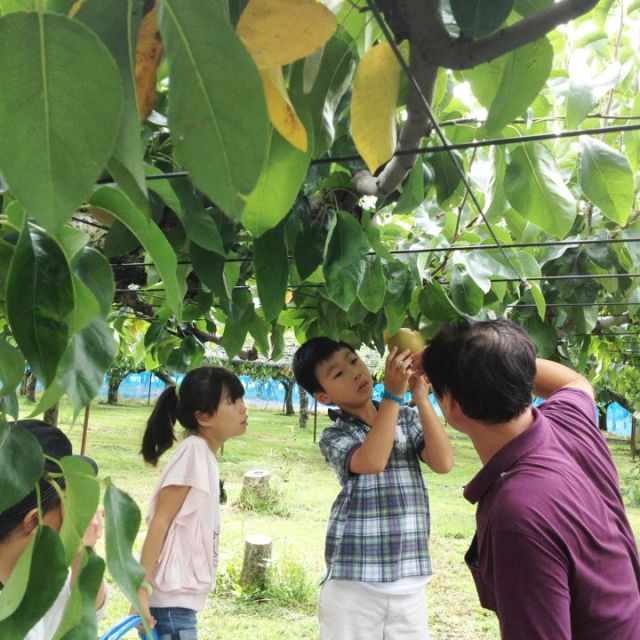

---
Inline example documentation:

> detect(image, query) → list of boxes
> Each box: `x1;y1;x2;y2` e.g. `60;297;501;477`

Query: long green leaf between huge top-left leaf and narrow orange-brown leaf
73;0;148;211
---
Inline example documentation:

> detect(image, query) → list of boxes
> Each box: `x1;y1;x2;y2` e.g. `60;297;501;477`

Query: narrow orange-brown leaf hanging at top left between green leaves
136;0;163;121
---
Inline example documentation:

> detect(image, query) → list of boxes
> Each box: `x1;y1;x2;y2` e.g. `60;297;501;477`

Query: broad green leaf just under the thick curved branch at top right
463;38;553;136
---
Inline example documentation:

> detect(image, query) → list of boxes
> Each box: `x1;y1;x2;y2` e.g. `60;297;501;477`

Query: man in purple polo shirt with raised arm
416;320;640;640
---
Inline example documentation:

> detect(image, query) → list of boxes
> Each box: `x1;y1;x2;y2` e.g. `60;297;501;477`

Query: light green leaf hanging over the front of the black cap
59;456;100;565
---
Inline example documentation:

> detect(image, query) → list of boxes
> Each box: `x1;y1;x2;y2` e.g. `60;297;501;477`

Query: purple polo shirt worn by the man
464;389;640;640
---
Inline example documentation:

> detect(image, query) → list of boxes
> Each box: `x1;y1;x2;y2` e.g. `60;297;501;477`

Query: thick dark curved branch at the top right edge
400;0;598;69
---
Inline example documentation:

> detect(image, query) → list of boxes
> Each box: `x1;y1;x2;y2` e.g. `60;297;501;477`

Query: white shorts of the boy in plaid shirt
318;580;429;640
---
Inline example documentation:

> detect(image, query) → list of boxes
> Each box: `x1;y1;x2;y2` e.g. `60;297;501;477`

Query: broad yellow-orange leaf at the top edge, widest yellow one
237;0;337;69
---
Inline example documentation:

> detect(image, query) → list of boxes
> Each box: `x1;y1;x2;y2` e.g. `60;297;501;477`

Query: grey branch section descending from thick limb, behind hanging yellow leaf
353;49;438;198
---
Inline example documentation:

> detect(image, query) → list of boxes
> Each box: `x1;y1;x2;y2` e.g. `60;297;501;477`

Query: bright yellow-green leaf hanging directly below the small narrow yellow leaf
242;108;313;236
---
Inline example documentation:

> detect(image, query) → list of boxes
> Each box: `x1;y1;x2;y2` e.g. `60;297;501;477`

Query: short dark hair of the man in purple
422;319;536;424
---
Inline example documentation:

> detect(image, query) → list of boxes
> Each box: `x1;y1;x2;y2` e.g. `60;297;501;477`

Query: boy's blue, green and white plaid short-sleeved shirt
320;407;432;582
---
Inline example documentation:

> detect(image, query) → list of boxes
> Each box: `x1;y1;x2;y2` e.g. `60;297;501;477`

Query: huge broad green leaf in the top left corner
0;13;122;231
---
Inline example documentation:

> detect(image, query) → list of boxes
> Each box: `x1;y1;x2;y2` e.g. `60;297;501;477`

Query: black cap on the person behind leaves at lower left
0;419;98;520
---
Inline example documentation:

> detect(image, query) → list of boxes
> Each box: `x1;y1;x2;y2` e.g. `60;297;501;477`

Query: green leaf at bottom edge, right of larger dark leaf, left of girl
54;548;105;640
